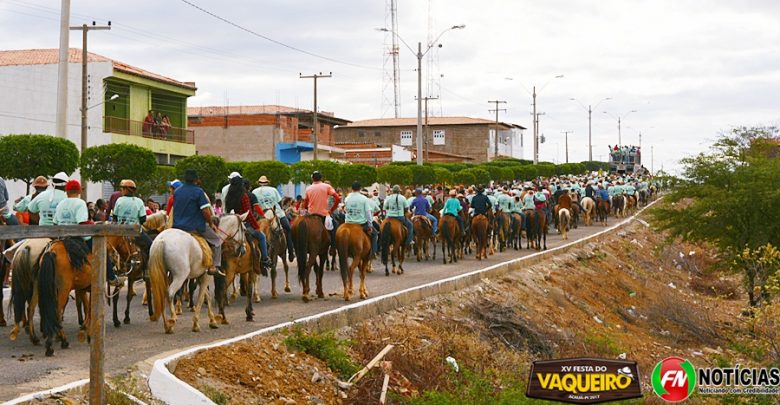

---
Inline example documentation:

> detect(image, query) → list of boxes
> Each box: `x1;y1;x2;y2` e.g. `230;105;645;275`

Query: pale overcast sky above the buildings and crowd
0;0;780;170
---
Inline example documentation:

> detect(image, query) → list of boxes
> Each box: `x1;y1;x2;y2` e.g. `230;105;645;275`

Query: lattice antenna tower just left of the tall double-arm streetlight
382;0;401;118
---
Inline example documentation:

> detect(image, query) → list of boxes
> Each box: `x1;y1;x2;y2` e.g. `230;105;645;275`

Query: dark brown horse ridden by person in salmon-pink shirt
292;214;330;302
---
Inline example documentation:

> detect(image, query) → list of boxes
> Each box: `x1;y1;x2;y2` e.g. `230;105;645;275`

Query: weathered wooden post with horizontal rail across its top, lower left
0;225;141;404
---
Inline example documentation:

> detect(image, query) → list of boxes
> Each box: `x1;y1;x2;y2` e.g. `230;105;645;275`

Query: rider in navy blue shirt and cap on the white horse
173;169;225;277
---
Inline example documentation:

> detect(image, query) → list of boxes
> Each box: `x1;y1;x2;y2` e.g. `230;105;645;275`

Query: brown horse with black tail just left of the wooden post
38;238;93;357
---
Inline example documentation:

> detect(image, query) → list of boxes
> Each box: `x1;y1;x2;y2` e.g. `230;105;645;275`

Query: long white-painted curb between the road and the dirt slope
149;198;662;405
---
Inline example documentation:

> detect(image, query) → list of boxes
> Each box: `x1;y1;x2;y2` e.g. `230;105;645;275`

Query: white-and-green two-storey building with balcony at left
0;49;196;201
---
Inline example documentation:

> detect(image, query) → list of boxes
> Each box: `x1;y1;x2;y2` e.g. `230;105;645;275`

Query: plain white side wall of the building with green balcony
0;62;113;201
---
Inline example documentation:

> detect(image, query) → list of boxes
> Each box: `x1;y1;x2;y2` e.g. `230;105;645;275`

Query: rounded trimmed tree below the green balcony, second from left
81;143;157;188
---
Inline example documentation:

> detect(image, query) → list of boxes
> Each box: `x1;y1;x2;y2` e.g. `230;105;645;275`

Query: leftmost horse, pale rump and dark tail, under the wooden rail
10;238;51;346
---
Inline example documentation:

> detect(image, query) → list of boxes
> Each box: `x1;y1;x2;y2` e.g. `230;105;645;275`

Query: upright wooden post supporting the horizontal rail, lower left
89;235;106;405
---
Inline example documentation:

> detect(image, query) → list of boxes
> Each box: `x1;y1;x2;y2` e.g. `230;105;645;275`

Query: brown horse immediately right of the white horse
214;214;254;325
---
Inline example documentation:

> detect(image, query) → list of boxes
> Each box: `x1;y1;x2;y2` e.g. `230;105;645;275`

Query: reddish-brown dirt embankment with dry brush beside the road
175;221;748;404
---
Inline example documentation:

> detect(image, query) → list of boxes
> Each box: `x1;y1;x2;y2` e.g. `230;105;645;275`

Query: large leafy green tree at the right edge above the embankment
652;127;780;305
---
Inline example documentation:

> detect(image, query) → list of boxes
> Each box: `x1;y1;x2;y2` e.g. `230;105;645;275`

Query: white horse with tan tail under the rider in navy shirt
149;213;247;333
